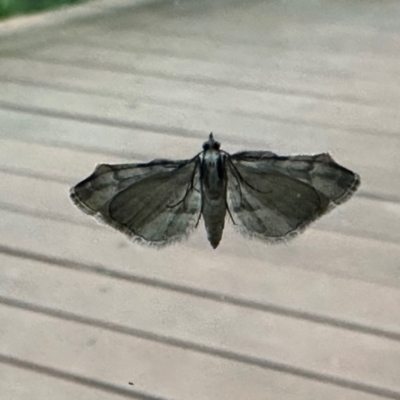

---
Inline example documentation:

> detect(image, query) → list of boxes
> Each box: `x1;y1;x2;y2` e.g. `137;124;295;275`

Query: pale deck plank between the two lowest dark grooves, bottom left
0;305;396;400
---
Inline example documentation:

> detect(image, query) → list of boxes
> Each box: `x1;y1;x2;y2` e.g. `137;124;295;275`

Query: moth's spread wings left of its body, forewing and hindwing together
71;157;201;246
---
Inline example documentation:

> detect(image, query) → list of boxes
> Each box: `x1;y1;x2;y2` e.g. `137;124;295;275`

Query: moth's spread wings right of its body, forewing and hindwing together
228;152;359;242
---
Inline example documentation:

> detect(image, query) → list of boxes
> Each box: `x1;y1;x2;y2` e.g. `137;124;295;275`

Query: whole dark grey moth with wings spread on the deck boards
70;133;360;249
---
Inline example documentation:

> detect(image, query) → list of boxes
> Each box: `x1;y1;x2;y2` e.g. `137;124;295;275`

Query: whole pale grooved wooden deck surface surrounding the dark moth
0;0;400;400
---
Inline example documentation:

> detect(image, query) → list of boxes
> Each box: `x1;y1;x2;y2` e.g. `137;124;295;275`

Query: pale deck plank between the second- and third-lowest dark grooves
2;253;400;390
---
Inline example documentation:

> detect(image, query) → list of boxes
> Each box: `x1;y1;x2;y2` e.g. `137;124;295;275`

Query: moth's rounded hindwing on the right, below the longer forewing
228;158;329;242
